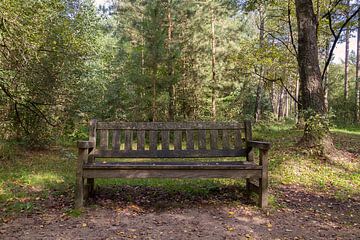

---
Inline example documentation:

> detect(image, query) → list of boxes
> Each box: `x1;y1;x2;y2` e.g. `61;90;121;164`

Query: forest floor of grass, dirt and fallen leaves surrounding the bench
0;126;360;239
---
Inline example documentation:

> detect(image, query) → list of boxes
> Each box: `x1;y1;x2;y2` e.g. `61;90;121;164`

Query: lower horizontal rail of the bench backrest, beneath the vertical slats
92;149;246;158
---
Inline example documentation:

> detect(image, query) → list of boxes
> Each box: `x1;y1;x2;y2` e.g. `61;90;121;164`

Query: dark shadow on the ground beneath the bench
89;185;256;212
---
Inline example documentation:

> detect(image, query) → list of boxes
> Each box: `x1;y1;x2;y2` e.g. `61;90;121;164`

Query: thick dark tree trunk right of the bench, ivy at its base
295;0;333;149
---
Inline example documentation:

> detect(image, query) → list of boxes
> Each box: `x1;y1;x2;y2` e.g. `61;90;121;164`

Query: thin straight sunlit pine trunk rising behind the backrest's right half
211;10;217;121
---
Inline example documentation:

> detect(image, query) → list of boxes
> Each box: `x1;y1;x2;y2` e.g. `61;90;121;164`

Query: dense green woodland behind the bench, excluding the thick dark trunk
0;0;360;147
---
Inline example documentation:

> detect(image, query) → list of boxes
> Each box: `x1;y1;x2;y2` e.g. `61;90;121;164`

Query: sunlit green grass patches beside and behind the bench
0;125;360;217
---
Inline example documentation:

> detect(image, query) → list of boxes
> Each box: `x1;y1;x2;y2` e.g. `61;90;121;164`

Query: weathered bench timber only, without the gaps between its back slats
75;120;270;209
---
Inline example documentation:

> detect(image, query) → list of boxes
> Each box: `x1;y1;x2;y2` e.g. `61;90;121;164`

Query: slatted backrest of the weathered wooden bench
89;120;252;158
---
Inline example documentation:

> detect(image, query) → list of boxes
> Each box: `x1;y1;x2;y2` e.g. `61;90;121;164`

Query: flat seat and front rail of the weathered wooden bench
83;162;262;179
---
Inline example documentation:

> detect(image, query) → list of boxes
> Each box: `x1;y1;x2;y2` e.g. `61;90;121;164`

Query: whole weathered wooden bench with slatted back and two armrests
75;120;270;208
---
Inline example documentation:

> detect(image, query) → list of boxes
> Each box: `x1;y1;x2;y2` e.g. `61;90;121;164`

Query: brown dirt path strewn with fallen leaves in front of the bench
0;186;360;240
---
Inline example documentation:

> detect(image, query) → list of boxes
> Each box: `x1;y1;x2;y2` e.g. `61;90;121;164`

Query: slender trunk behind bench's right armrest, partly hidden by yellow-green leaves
254;4;265;122
